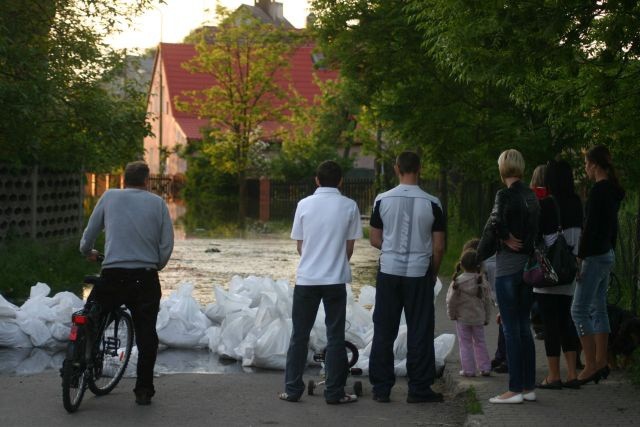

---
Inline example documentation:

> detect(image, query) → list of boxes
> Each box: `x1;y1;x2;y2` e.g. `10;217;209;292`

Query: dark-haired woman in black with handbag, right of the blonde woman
531;161;583;389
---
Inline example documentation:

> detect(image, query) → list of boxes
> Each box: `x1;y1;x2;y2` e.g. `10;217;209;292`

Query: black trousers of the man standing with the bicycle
88;268;162;394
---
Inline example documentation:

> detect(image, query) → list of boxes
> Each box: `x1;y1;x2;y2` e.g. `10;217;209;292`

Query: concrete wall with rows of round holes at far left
0;166;83;242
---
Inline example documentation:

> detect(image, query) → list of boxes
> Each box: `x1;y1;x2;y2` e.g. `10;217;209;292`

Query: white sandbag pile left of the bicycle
0;283;84;349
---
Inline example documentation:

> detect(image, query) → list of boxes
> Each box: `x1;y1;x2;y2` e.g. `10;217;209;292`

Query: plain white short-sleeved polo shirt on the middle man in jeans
291;187;362;286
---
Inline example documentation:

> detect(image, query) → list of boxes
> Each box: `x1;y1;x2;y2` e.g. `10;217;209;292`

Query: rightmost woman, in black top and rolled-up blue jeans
571;145;624;384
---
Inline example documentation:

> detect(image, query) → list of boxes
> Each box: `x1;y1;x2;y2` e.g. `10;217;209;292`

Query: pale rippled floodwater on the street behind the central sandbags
160;236;379;306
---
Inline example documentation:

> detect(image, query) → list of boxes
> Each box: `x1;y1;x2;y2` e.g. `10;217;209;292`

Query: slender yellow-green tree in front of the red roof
178;6;302;220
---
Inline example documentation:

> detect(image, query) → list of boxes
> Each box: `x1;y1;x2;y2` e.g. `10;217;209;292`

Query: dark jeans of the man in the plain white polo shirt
284;284;349;400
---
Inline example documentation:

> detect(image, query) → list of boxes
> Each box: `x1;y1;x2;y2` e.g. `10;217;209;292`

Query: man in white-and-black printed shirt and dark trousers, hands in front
369;151;445;403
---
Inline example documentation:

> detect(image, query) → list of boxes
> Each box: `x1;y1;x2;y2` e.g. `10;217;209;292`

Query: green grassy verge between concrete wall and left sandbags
0;238;99;304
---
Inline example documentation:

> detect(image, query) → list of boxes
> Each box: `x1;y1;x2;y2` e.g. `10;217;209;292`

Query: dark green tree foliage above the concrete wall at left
0;0;154;171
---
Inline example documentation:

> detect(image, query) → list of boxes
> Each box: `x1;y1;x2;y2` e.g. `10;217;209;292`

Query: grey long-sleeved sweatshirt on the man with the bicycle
80;188;173;270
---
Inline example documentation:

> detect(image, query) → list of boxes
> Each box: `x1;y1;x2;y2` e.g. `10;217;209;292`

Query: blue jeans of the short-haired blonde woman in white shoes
496;271;536;393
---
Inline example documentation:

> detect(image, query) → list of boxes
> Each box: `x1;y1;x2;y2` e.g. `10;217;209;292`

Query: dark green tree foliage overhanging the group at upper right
311;0;640;189
